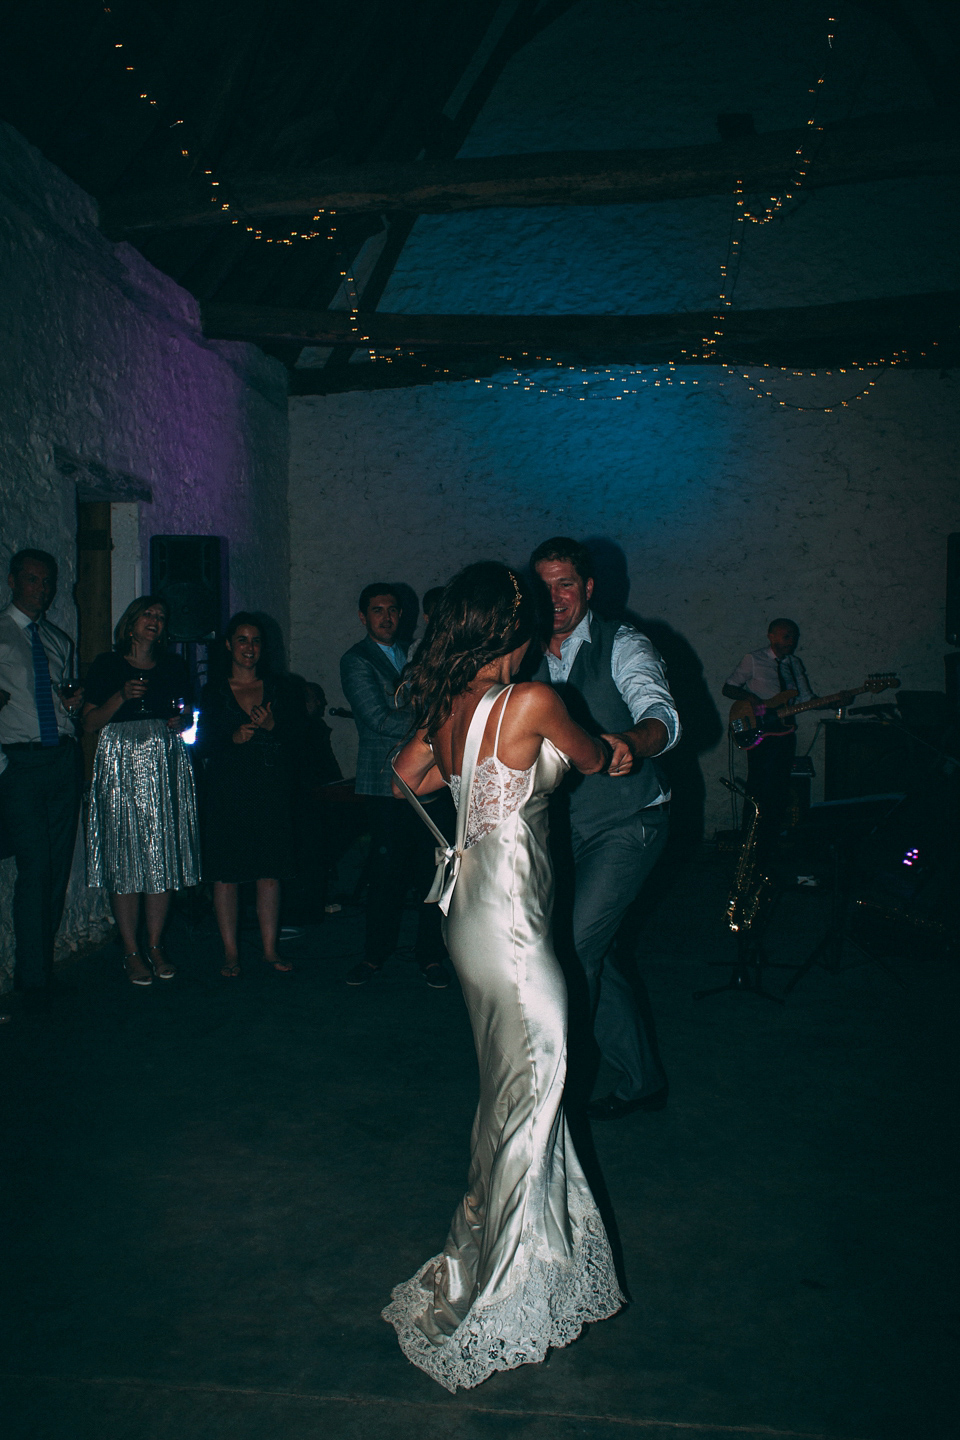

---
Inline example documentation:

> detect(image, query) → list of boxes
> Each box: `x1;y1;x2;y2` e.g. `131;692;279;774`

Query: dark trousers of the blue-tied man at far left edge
0;740;82;989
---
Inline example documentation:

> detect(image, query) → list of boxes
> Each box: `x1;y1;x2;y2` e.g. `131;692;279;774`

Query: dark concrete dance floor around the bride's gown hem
0;857;960;1440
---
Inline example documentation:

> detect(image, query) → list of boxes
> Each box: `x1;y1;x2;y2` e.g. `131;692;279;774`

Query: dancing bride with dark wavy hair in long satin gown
383;562;629;1391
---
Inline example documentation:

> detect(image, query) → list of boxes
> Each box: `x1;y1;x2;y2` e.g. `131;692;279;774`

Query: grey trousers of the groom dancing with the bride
571;805;669;1100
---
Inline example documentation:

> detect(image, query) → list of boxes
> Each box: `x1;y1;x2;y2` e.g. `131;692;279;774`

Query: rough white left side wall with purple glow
0;125;288;968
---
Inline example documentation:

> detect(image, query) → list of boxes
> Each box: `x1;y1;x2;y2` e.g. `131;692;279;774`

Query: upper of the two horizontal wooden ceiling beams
102;111;960;236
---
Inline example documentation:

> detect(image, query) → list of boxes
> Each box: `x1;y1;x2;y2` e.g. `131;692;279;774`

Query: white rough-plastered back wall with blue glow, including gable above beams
291;0;960;828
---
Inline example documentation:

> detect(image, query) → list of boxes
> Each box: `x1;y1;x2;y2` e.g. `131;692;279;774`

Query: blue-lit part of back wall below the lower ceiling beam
291;369;960;829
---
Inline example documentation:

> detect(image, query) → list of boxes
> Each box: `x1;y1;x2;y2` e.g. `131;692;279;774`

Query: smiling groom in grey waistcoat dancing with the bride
530;536;679;1120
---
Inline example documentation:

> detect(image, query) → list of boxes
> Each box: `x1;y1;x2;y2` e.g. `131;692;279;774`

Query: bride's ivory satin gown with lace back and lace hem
383;687;623;1391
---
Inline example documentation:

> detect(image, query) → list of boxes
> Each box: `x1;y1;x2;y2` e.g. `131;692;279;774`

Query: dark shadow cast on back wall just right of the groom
586;536;724;860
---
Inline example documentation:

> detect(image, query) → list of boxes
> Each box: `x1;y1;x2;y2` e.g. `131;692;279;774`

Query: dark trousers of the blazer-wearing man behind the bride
364;795;446;969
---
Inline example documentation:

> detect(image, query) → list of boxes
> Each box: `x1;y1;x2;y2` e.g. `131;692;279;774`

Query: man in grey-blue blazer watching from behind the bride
340;580;449;989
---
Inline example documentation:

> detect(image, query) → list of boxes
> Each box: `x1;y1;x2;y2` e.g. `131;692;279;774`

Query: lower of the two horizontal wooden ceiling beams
203;291;960;366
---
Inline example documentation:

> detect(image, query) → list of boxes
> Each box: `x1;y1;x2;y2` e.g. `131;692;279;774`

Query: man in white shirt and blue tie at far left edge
0;550;83;1001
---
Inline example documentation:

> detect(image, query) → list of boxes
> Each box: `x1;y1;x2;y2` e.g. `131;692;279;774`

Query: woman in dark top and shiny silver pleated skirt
83;595;200;985
